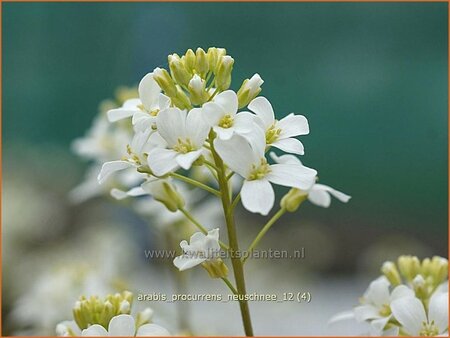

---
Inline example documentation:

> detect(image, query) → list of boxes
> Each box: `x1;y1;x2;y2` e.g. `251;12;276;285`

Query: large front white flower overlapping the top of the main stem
214;135;317;215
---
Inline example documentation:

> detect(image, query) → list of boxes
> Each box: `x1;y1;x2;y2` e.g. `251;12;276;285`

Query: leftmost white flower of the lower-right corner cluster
353;276;414;335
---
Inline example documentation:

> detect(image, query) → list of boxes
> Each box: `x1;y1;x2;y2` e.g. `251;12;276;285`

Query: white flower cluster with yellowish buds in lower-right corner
330;256;448;336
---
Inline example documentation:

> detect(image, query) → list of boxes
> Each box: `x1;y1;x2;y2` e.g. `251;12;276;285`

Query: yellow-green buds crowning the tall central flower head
153;47;264;109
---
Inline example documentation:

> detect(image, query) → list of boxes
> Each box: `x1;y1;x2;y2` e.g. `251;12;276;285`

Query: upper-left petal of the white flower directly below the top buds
156;108;186;147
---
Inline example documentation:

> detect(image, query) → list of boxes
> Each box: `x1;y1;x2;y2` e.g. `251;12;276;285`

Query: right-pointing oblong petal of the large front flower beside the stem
266;164;317;190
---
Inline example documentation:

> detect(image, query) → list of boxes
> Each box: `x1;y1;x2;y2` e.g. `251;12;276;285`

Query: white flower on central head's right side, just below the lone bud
248;96;309;155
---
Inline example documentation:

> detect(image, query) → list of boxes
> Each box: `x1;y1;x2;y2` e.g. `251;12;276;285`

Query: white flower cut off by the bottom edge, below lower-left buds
81;315;170;337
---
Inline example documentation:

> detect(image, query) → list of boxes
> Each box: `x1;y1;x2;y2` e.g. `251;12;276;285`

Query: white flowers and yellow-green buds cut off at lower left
56;291;170;337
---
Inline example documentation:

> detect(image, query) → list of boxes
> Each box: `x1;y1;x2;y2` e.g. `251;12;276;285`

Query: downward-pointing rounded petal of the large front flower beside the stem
241;179;275;216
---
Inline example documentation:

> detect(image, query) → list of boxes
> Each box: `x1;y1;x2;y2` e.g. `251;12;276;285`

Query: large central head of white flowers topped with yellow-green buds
98;48;349;215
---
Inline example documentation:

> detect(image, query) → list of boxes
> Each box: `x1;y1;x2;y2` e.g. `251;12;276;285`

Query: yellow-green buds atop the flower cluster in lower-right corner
381;256;448;299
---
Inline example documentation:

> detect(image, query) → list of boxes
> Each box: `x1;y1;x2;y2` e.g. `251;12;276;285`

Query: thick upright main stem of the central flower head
210;134;253;336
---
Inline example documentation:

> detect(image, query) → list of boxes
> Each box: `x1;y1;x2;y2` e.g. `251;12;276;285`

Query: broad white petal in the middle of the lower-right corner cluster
391;297;427;336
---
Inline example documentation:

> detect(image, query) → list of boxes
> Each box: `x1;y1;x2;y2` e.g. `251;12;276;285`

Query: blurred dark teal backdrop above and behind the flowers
2;3;448;250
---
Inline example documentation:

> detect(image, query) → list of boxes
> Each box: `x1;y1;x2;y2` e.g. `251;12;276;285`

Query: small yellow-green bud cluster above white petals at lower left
73;291;133;330
